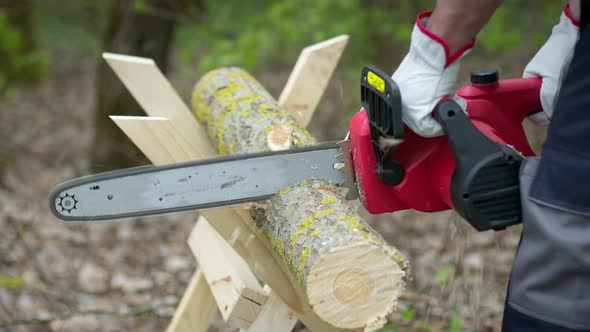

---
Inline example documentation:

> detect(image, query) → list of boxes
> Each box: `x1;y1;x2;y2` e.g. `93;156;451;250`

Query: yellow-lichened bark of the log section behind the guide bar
192;68;317;155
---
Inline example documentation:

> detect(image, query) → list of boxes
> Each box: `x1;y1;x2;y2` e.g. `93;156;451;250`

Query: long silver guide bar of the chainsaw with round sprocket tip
49;142;345;222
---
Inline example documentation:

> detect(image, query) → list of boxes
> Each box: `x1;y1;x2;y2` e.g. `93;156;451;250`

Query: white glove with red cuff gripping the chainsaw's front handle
392;12;475;137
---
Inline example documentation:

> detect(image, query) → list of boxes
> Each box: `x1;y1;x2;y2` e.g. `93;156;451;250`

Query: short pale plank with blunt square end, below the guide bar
188;216;267;329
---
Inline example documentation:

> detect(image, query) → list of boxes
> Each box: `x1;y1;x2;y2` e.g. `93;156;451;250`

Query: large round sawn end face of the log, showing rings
306;243;405;328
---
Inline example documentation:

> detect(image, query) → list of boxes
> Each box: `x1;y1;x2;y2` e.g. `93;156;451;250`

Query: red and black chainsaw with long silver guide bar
49;66;541;231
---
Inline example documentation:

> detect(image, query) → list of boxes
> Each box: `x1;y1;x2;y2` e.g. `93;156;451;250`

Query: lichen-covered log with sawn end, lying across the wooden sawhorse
192;68;407;328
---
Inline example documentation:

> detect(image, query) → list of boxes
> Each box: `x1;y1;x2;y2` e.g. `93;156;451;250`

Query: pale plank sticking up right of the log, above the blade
279;35;348;127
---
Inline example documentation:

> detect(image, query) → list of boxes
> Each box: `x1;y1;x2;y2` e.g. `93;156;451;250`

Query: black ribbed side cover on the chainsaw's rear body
435;100;522;231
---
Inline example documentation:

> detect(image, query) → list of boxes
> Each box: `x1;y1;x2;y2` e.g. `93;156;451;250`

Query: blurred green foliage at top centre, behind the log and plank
177;0;432;72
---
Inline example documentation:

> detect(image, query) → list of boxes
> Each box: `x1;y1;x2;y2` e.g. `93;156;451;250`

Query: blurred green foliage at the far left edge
0;10;48;92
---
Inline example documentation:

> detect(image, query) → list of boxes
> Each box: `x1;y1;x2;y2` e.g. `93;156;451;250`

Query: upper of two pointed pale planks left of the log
102;53;214;155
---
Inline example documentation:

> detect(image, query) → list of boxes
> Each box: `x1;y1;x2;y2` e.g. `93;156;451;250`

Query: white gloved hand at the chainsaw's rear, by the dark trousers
523;5;579;126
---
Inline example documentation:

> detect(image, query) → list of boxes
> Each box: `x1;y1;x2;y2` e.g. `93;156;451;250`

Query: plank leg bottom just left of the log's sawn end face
248;286;297;332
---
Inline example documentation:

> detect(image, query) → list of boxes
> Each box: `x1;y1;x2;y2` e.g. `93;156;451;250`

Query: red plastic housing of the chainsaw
350;78;542;214
